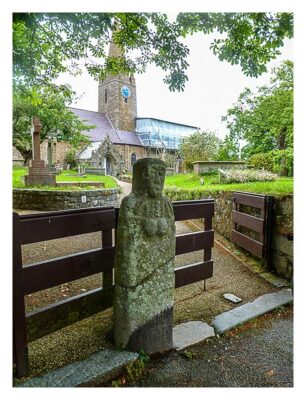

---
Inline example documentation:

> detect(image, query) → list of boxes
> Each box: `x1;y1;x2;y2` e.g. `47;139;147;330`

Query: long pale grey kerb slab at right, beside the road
212;289;293;333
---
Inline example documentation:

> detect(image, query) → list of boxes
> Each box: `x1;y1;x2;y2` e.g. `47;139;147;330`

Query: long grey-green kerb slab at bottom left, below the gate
17;349;138;387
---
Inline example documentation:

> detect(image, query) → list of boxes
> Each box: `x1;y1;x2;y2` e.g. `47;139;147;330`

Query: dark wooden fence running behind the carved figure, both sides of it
13;200;214;377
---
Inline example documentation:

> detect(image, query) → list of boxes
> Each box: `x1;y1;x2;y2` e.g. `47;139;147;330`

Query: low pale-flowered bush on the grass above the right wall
220;169;277;183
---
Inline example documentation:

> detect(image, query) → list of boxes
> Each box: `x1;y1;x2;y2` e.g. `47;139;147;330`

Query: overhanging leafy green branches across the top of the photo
13;13;293;90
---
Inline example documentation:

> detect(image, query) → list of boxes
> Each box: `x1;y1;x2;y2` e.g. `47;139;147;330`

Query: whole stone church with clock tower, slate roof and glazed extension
70;42;198;175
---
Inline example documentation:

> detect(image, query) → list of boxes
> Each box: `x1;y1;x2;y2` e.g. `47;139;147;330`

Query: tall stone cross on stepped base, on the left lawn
24;117;56;186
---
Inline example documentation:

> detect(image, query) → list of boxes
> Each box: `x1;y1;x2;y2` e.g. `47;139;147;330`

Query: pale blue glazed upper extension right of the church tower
136;118;198;150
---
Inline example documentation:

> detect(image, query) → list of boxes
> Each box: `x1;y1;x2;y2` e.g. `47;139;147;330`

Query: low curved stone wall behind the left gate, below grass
13;189;120;211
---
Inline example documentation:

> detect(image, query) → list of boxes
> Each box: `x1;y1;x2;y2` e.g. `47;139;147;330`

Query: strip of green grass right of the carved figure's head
165;174;293;194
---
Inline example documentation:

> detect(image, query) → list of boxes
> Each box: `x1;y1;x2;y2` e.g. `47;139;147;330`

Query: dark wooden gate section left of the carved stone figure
13;207;115;377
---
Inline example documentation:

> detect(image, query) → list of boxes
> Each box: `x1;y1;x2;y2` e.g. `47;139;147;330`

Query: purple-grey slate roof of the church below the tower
70;107;142;146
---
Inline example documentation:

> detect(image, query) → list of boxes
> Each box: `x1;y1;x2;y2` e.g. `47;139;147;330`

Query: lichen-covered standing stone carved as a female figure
114;158;175;354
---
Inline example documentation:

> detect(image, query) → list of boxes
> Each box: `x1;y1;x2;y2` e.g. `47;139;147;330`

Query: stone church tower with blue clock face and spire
98;42;137;132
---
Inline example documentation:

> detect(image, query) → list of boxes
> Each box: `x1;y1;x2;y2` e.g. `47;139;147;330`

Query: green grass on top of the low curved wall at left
13;167;119;190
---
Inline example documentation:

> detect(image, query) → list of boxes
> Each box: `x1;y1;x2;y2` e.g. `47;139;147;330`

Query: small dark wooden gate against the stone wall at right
231;192;273;267
